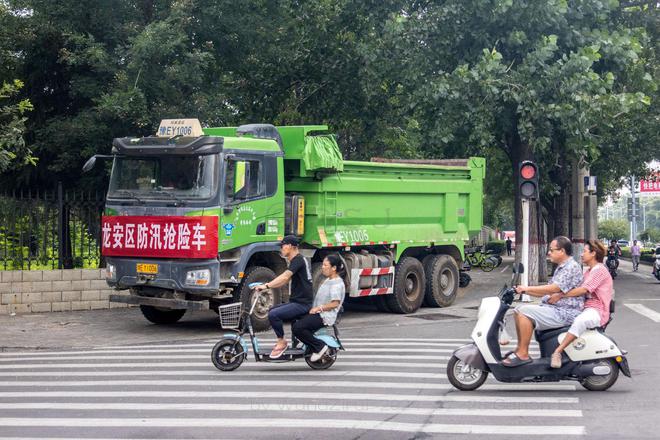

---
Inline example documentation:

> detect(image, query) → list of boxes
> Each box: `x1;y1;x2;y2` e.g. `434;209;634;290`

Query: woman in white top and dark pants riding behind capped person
293;254;346;362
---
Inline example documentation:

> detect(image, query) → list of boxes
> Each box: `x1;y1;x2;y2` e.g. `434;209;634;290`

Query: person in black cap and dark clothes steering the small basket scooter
255;235;314;359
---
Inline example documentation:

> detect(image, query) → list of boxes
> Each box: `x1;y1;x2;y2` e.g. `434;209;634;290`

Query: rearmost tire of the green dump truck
423;255;459;307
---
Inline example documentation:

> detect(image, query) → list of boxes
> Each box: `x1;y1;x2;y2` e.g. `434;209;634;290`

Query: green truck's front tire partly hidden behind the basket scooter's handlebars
234;266;282;332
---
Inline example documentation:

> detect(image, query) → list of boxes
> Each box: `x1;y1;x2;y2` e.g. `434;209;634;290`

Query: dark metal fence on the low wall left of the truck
0;182;105;270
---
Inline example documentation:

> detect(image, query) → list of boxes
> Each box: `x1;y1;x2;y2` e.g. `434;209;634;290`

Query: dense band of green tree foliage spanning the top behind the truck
0;0;660;237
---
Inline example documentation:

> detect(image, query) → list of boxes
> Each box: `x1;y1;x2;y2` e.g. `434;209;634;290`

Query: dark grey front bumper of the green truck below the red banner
106;257;220;295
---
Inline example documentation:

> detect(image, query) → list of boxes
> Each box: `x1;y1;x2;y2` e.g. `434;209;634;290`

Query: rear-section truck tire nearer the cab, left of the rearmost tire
387;257;426;314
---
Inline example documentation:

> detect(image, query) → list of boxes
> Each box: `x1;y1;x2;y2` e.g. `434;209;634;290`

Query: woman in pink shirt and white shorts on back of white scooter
548;240;613;368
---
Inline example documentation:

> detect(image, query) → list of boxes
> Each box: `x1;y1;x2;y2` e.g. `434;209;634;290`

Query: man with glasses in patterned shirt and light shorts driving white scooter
502;236;584;367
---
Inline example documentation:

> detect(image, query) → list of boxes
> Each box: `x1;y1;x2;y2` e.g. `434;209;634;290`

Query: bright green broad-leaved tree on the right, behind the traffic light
360;0;658;279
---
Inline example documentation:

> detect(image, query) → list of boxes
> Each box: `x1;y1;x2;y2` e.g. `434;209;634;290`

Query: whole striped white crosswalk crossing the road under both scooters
0;338;585;440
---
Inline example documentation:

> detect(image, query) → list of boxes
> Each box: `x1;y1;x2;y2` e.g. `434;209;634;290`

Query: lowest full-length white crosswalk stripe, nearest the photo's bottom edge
0;417;585;436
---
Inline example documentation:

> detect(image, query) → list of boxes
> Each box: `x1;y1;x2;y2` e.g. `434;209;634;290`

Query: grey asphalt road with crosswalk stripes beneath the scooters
0;256;660;440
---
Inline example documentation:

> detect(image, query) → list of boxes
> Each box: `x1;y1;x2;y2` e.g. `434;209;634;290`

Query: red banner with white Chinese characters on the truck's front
101;215;218;258
